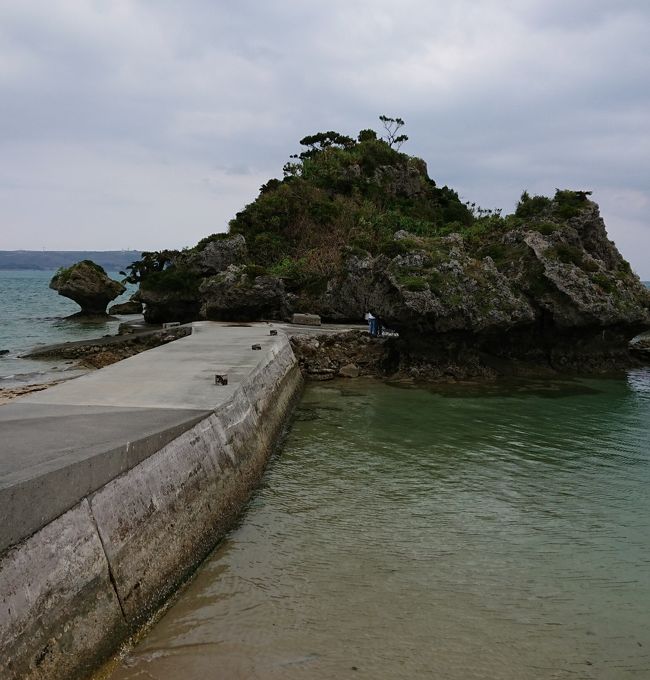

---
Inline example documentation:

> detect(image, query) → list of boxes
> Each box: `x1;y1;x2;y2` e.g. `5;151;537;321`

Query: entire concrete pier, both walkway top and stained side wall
0;322;301;680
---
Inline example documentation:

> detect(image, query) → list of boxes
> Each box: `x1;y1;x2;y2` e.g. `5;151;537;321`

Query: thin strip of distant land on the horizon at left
0;250;142;271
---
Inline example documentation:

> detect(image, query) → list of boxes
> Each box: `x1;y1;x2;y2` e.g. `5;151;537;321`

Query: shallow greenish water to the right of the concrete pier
101;371;650;680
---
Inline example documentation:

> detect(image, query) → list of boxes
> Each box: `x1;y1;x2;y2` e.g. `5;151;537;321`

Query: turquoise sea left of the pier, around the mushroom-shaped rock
0;271;134;387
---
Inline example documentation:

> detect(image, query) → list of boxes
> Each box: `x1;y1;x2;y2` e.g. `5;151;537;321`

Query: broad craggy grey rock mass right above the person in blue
319;234;534;334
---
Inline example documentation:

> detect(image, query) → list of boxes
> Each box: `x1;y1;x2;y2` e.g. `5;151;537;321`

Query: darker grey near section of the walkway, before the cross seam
0;401;209;553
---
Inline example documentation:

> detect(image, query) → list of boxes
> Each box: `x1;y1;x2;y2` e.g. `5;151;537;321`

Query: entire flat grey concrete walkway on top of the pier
0;322;294;553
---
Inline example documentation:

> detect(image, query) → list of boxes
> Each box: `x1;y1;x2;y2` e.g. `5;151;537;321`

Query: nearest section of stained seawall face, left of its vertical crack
0;501;127;680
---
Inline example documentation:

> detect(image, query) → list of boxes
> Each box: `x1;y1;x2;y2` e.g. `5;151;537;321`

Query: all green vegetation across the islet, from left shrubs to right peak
125;116;604;299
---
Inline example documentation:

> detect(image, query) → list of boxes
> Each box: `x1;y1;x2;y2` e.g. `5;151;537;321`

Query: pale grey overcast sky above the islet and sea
0;0;650;279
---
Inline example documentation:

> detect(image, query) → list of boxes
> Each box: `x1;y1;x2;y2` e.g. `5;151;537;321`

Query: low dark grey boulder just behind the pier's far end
200;265;288;321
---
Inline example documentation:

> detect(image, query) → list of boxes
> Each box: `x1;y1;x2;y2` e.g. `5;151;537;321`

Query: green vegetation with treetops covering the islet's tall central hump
230;116;476;282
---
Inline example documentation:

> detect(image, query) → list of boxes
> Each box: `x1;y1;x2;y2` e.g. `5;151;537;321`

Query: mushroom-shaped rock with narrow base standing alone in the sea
50;260;126;316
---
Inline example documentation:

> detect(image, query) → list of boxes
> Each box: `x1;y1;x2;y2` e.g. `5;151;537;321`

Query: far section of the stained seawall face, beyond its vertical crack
90;345;300;620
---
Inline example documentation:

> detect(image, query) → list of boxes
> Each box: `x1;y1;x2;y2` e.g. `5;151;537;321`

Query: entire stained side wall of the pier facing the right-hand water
0;331;302;680
